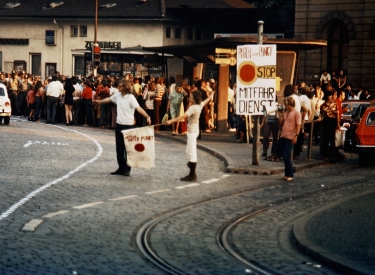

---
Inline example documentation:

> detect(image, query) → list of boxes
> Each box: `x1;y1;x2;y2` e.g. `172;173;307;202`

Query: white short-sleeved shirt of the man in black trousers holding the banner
111;93;139;125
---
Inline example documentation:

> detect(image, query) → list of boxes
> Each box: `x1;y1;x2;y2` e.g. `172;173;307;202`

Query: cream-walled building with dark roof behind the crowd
0;0;294;81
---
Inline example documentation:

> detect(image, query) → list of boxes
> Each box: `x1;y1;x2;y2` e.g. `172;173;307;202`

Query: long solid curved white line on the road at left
0;125;103;221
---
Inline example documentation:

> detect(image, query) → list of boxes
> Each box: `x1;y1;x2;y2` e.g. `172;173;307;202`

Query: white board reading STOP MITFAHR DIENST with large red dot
236;45;276;115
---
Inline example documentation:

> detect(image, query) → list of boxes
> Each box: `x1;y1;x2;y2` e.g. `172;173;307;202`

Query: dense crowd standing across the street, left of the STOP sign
0;71;215;135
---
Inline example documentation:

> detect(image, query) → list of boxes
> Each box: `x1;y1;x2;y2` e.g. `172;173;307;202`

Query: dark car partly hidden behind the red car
341;100;372;152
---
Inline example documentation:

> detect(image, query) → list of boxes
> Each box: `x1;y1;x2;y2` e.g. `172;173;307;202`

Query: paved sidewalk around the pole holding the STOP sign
156;131;329;175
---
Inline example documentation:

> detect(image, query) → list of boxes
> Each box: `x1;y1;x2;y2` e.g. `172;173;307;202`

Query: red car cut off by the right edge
356;107;375;166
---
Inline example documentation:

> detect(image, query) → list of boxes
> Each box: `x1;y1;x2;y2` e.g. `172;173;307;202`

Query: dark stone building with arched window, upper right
294;0;375;89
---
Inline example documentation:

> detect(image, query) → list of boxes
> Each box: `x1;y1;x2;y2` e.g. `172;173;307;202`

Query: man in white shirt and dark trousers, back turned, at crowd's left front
47;75;64;124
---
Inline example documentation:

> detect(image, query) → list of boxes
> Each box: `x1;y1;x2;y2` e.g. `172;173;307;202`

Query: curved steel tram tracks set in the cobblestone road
135;168;370;275
